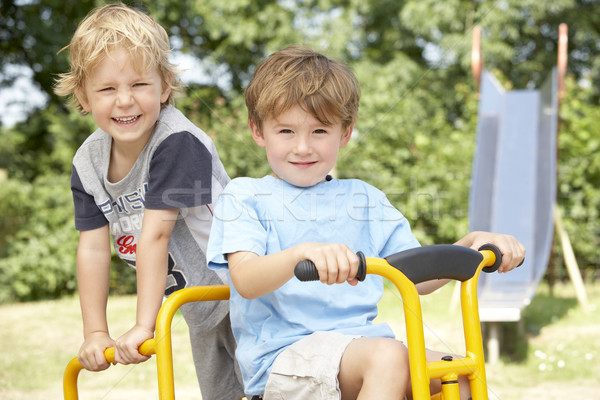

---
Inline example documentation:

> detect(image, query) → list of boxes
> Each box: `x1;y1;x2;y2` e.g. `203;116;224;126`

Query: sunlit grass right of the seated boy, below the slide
379;283;600;400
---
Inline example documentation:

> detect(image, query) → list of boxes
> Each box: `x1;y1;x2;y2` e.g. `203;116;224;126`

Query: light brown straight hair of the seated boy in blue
245;46;360;130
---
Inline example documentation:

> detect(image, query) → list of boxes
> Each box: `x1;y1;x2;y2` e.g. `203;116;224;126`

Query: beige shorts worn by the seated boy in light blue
263;332;360;400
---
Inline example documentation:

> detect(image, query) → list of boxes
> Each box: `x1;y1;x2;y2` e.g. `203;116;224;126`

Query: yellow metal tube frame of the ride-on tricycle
63;250;496;400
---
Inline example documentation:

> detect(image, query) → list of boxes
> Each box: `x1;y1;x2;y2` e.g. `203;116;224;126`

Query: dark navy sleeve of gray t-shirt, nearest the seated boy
146;132;212;210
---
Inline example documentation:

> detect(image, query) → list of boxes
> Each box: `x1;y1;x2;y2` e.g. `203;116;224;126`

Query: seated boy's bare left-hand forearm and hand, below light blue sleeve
227;243;358;299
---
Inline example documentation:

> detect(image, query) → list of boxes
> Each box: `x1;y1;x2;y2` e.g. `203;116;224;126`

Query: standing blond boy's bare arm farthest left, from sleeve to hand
77;225;114;371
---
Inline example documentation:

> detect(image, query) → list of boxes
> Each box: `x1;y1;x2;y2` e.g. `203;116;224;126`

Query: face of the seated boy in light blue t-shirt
249;105;352;187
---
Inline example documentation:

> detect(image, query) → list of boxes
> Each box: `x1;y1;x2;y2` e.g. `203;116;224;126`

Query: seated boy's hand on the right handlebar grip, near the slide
456;231;525;273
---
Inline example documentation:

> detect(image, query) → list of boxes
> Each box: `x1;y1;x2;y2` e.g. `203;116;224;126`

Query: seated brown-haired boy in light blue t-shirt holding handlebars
208;47;525;400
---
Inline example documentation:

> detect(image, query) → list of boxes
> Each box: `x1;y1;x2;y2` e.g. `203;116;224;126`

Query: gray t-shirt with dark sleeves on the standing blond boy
71;106;229;330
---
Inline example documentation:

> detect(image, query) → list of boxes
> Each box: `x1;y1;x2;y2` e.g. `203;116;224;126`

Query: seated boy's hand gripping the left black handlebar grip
305;243;358;286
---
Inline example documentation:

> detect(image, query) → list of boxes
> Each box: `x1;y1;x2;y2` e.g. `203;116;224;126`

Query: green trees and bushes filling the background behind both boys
0;0;600;301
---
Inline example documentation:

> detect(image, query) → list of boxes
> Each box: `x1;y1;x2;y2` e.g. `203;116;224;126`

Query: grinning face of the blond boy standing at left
78;49;170;150
